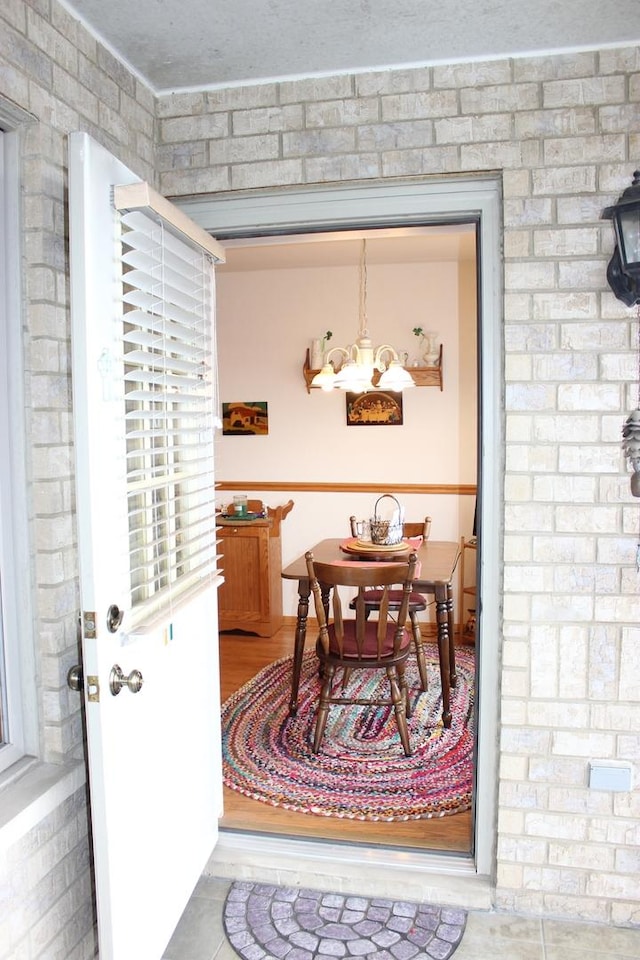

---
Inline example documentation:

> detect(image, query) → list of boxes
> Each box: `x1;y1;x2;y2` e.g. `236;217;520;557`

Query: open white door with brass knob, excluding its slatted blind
69;134;222;960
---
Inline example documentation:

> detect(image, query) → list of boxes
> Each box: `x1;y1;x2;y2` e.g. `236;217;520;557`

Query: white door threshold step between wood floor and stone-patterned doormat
204;831;493;910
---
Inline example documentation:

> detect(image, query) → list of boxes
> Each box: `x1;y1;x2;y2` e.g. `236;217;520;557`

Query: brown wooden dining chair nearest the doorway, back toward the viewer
305;553;417;756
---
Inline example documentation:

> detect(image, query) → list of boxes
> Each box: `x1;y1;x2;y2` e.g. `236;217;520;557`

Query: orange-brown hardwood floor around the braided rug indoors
220;625;472;853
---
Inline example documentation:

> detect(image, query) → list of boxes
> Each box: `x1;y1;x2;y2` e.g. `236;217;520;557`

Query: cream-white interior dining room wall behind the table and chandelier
216;255;476;616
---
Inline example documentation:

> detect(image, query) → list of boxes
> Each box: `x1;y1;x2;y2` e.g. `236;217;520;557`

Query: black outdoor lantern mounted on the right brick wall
602;170;640;307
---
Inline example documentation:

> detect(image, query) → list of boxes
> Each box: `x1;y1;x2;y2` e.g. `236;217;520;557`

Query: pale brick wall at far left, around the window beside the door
0;0;155;960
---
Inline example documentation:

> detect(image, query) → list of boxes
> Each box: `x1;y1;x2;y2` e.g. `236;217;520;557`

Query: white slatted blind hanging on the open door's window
120;210;218;627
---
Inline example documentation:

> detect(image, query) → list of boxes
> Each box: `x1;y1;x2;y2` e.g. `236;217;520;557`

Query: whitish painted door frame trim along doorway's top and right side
174;174;504;886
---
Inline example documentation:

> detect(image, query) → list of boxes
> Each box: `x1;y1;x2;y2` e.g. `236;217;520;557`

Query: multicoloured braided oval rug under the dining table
222;644;474;821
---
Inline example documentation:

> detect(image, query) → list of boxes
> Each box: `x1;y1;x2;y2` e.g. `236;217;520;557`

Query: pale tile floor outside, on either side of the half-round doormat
163;877;640;960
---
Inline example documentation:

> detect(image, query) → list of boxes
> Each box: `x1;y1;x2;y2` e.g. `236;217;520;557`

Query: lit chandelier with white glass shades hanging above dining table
311;240;415;393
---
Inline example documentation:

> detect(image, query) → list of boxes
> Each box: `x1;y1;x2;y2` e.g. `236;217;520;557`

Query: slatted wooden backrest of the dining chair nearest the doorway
305;553;418;662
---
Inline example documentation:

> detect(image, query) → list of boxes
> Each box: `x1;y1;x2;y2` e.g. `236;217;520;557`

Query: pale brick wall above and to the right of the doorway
158;48;640;924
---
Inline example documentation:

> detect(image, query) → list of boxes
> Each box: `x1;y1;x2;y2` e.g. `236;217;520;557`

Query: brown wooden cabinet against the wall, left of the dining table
218;501;293;637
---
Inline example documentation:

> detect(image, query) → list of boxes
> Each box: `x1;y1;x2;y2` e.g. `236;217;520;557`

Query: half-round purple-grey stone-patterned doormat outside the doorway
223;881;467;960
